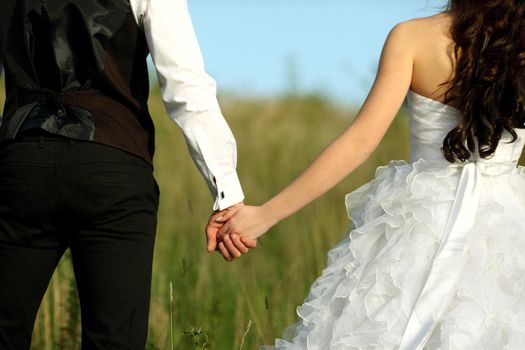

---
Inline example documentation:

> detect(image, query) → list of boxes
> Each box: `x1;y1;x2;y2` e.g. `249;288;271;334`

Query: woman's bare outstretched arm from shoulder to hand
219;23;414;243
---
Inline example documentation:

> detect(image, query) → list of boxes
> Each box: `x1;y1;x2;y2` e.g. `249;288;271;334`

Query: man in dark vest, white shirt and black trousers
0;0;252;350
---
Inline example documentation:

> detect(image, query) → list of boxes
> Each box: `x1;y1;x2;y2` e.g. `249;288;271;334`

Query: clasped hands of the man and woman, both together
205;203;271;261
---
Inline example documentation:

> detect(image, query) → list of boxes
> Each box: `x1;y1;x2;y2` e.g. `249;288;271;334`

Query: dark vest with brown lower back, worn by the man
0;0;154;162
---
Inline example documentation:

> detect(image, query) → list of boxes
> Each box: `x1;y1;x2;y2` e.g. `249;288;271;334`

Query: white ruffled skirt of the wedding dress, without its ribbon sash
263;160;525;350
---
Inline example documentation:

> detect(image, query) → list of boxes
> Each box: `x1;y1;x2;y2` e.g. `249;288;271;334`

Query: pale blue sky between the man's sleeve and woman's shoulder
189;0;446;104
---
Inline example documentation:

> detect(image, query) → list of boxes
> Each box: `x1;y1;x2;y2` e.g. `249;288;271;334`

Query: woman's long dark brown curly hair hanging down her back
443;0;525;163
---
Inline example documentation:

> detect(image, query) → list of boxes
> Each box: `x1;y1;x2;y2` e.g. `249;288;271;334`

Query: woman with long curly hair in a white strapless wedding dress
208;0;525;350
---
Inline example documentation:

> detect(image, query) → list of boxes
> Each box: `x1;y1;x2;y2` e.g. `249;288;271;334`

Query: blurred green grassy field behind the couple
0;83;520;350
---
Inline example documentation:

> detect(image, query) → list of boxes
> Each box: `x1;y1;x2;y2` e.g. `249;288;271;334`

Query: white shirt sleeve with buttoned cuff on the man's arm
131;0;244;210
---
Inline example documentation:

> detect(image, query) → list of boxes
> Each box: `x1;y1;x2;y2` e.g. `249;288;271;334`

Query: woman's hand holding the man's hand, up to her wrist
218;206;275;242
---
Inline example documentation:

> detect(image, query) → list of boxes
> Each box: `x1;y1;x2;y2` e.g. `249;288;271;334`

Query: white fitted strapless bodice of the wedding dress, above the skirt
408;90;525;163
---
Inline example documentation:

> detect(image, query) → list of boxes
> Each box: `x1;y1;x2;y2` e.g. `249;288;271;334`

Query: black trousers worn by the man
0;135;158;350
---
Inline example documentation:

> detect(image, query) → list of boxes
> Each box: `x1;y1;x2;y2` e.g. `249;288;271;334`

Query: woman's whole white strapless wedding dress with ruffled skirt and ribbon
263;91;525;350
